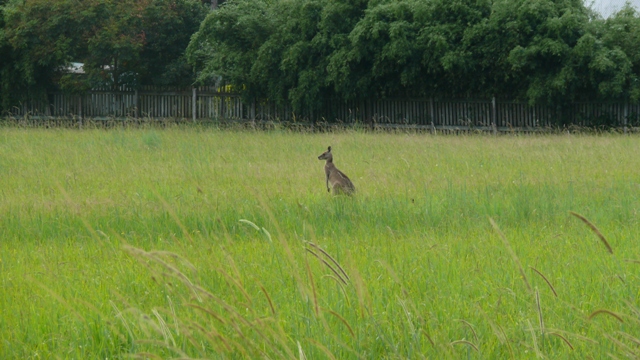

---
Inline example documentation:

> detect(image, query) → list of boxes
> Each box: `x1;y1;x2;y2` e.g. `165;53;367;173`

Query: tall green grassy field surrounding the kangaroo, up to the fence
0;128;640;359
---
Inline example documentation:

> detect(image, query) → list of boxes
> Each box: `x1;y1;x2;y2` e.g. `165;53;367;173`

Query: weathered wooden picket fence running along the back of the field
9;87;640;132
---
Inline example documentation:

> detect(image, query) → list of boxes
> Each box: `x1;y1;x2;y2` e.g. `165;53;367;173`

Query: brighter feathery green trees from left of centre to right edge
187;0;640;111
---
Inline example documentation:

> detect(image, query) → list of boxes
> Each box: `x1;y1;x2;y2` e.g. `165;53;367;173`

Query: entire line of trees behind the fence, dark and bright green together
0;0;640;112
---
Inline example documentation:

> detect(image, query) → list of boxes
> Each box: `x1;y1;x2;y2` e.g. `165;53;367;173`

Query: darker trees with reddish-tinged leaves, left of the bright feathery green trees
0;0;210;110
